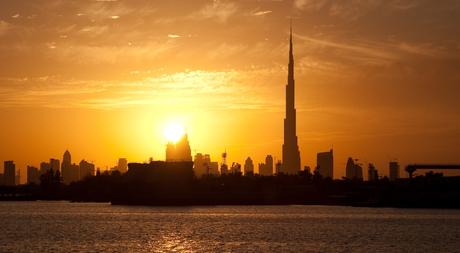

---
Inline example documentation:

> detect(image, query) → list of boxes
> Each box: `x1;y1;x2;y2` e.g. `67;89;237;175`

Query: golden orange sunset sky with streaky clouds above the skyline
0;0;460;182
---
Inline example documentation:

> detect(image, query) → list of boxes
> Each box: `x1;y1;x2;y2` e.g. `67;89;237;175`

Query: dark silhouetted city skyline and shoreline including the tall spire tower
0;24;460;208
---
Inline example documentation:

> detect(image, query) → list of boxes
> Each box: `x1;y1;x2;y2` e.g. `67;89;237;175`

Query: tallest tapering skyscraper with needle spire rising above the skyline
281;23;300;175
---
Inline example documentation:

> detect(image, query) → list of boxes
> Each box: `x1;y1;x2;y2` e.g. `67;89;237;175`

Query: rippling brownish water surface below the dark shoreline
0;202;460;252
